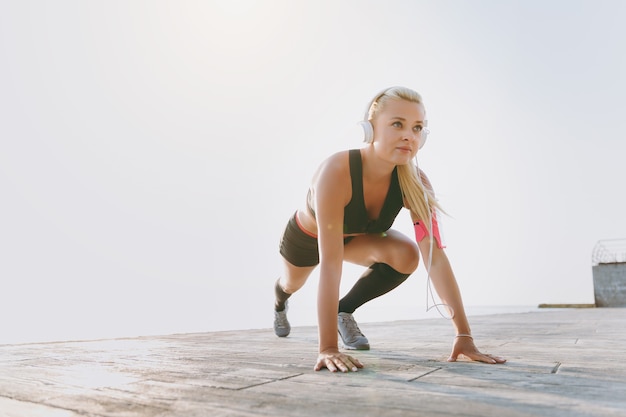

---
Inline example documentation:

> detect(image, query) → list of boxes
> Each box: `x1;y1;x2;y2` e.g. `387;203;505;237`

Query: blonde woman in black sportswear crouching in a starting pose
274;87;505;372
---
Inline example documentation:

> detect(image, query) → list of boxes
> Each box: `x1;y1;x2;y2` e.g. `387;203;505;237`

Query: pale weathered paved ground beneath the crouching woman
0;308;626;417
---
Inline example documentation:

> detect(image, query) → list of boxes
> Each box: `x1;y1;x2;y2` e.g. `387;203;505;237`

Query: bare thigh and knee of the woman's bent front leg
344;229;419;274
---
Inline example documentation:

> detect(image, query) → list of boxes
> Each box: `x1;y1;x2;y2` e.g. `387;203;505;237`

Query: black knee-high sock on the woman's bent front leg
339;263;411;314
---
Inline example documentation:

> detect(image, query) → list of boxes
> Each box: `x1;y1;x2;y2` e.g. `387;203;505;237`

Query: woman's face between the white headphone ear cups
372;99;426;165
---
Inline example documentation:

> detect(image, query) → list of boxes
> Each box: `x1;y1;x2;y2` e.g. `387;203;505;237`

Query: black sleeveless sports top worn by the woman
307;149;404;234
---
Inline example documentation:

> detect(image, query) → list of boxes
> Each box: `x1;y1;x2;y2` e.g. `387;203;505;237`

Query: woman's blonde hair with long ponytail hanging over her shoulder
365;87;443;232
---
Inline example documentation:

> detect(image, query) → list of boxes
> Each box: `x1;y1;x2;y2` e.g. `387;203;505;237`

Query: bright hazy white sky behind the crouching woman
0;0;626;343
